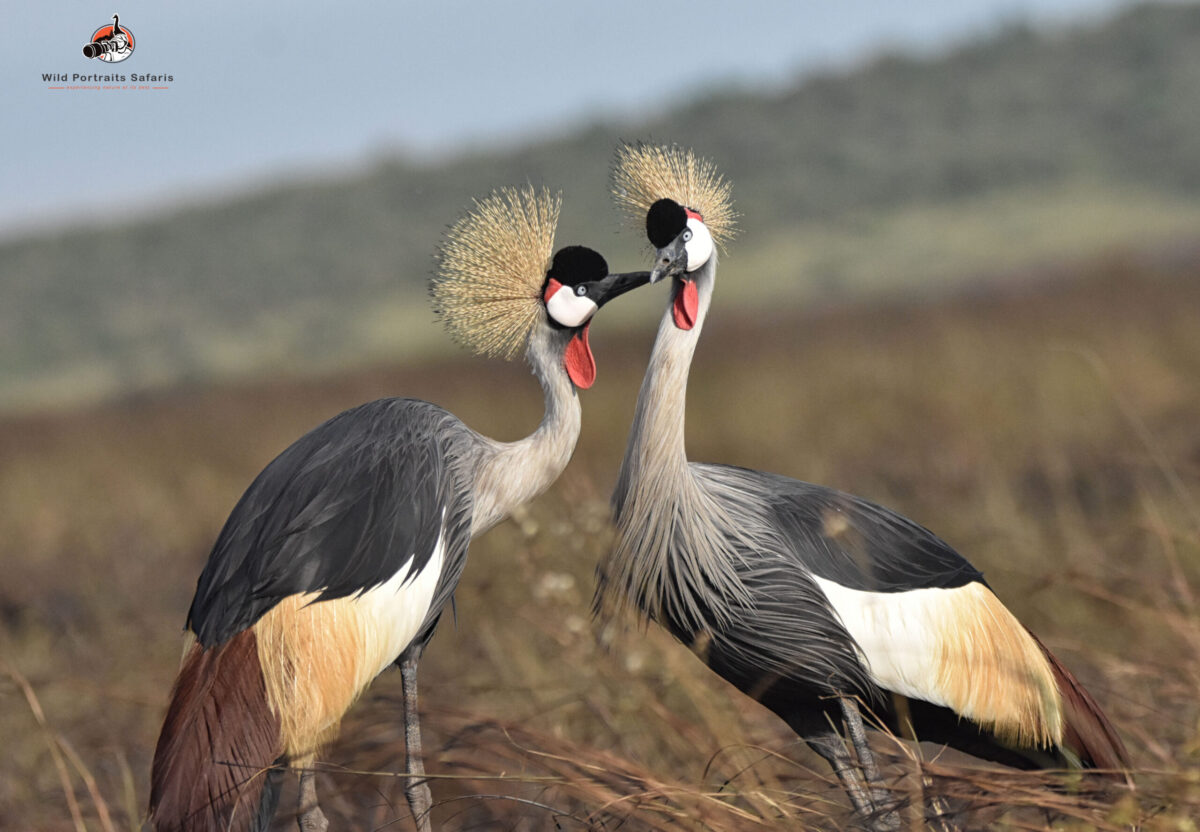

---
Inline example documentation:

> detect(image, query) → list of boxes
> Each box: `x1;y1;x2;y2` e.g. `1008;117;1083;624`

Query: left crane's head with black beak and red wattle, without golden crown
541;246;650;389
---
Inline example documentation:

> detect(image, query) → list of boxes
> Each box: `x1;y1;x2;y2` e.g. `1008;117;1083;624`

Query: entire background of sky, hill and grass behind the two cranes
0;0;1200;830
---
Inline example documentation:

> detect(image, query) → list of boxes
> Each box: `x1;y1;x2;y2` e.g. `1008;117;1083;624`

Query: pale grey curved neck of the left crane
470;327;581;537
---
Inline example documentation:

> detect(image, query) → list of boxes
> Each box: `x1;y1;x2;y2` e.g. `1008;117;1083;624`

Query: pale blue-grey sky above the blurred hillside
0;0;1147;237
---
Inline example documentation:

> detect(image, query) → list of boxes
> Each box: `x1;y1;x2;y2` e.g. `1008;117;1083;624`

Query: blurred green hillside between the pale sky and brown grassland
0;4;1200;409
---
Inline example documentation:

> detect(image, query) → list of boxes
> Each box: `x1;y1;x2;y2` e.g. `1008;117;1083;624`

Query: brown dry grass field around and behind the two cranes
0;249;1200;832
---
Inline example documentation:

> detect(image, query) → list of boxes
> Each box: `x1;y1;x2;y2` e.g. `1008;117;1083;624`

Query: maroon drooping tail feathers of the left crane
150;630;282;832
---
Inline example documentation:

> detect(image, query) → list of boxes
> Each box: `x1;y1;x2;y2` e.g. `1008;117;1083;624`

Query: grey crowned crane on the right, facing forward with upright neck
594;145;1128;830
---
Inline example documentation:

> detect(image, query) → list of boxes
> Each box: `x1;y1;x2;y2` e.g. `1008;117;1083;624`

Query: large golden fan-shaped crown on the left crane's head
430;186;563;360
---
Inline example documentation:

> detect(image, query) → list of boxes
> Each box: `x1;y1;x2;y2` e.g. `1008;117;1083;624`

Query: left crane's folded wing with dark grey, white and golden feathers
175;399;475;765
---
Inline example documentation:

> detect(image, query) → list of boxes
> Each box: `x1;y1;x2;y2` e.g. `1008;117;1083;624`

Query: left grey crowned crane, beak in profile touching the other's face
150;188;649;832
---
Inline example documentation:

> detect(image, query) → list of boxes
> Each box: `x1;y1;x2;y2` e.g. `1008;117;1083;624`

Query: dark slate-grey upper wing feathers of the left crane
187;399;474;646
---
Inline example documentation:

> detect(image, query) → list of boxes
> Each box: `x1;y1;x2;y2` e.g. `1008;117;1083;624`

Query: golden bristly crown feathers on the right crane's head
612;142;738;249
